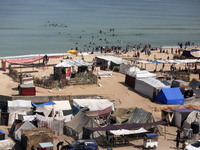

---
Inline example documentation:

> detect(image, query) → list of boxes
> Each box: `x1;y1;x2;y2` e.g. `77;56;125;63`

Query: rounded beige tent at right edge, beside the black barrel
182;110;200;129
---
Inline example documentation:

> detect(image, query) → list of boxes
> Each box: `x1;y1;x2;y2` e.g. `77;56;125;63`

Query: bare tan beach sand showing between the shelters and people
0;49;200;150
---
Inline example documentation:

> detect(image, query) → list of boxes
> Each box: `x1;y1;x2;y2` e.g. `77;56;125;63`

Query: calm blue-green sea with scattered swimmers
0;0;200;57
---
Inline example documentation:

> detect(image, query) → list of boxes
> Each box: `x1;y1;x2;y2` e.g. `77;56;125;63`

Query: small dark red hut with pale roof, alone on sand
19;84;36;96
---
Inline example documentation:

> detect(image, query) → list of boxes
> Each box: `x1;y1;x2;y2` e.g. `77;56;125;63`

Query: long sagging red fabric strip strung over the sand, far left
6;56;43;65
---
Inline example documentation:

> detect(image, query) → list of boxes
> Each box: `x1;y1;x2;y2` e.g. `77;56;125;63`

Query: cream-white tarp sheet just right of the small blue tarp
52;100;72;116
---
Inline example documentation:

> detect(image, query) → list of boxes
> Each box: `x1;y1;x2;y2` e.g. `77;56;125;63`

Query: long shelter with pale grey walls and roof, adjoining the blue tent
135;78;169;100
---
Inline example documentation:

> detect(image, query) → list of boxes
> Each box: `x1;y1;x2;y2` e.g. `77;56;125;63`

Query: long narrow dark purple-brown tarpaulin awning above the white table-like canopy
84;121;168;131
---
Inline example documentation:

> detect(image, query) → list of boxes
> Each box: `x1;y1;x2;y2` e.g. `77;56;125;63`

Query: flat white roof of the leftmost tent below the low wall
8;100;33;108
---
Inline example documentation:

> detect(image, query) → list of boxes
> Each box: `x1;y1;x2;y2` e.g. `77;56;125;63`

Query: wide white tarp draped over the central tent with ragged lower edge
73;99;114;111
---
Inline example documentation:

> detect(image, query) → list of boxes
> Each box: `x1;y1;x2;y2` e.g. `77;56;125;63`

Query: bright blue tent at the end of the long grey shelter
156;88;184;105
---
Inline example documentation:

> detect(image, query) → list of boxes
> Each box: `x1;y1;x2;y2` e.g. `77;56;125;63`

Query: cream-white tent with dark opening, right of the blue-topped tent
52;100;72;117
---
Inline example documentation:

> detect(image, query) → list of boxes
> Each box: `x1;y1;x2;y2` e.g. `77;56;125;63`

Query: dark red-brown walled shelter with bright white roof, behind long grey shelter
125;70;156;88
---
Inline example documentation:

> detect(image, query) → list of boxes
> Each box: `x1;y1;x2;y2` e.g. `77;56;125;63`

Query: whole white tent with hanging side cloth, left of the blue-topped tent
8;100;33;125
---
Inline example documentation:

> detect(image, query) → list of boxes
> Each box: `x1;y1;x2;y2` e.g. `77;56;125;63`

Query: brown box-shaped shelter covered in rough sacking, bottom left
21;128;53;150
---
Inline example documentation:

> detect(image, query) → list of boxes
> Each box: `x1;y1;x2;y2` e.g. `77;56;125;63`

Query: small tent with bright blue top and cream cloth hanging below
32;101;55;117
